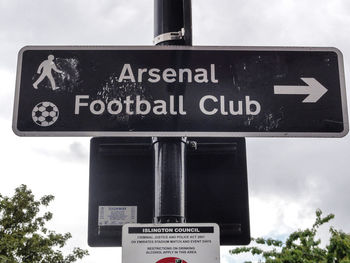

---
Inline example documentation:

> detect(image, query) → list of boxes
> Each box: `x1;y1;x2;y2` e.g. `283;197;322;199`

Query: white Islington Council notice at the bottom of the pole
122;223;220;263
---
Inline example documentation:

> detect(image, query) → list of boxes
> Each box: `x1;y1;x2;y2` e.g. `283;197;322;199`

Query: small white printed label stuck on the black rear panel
98;206;137;226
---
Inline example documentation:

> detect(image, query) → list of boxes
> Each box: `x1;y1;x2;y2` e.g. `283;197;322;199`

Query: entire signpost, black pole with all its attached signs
13;0;349;263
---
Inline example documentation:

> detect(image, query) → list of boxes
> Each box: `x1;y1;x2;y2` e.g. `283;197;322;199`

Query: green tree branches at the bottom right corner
230;210;350;263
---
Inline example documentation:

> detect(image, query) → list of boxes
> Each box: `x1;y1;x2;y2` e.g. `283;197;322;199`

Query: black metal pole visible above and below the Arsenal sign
153;0;192;223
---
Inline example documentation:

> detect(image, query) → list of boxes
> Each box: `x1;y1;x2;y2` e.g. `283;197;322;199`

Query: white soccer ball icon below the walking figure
32;101;59;127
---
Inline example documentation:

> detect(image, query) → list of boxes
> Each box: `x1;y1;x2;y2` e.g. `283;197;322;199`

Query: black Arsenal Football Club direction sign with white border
13;46;348;137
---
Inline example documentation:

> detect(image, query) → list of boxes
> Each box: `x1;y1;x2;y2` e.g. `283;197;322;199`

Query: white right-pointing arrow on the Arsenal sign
274;78;328;103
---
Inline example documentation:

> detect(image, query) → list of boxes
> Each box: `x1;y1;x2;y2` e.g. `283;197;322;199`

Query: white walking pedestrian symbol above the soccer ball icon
33;55;64;90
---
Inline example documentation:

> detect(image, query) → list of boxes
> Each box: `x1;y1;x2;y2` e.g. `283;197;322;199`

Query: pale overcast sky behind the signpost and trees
0;0;350;263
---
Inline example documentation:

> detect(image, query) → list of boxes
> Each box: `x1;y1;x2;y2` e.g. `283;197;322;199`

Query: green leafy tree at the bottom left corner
0;185;88;263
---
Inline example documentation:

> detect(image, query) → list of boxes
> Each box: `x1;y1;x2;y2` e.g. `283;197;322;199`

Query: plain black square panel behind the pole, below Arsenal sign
88;137;250;247
